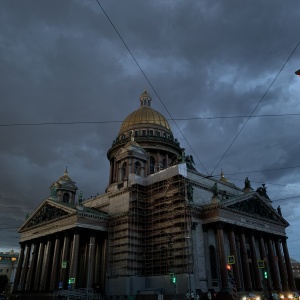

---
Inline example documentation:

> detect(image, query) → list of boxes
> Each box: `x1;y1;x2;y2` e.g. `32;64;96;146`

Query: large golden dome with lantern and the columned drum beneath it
107;91;182;187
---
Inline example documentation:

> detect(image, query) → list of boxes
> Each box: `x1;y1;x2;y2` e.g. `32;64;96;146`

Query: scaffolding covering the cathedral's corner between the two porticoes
108;169;192;278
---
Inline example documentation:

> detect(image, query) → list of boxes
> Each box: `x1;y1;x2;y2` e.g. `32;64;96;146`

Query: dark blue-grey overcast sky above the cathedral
0;0;300;261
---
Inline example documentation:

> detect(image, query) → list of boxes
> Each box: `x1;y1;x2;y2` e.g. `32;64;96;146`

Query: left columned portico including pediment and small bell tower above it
14;171;107;292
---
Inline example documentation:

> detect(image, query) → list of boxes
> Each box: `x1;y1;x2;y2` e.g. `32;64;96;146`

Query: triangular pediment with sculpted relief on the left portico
19;200;76;232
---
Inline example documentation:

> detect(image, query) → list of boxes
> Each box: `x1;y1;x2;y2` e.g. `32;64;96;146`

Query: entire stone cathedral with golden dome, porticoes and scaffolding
14;91;295;299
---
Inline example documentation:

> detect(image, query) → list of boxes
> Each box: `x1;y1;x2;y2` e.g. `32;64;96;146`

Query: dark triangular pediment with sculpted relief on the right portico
223;193;288;224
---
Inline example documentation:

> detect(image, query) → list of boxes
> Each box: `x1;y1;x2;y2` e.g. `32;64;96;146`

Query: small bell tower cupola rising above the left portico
50;168;78;204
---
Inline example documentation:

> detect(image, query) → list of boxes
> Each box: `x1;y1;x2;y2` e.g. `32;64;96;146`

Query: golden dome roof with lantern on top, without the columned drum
119;90;171;135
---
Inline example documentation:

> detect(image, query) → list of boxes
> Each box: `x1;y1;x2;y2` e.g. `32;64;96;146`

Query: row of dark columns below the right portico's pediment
214;222;296;291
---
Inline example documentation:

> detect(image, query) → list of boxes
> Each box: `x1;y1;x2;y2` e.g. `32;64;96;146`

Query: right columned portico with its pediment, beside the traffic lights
193;192;296;291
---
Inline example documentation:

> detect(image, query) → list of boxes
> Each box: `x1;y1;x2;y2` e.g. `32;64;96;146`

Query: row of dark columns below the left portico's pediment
13;229;106;293
